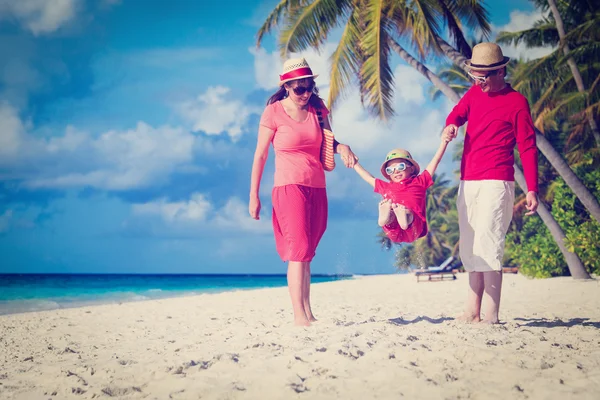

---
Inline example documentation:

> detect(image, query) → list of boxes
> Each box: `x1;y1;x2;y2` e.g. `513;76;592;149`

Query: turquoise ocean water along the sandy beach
0;274;351;315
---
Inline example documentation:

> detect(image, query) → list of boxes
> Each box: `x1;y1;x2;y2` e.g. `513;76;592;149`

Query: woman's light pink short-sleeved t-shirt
260;101;329;188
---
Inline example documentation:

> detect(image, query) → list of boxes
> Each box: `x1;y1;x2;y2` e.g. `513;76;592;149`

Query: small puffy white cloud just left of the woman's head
177;86;261;140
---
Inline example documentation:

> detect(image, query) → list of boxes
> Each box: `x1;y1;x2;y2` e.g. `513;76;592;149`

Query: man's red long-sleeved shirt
446;85;538;192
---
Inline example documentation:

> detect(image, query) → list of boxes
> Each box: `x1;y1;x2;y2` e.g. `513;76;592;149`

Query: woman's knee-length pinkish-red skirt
272;185;327;262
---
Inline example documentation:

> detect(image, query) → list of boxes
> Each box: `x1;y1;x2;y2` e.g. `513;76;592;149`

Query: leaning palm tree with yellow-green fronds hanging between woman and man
257;0;589;277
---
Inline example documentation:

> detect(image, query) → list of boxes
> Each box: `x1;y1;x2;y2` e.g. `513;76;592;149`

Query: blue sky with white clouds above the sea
0;0;543;273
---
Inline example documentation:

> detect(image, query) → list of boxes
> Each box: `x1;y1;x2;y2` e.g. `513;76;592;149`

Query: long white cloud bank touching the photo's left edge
0;104;206;190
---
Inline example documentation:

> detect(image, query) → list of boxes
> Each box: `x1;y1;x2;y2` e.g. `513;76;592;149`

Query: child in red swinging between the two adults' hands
354;133;453;243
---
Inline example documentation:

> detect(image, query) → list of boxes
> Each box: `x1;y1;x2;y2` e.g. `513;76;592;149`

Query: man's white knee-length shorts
457;180;515;272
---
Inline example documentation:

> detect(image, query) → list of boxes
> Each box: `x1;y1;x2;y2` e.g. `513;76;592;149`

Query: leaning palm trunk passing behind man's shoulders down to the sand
390;40;590;279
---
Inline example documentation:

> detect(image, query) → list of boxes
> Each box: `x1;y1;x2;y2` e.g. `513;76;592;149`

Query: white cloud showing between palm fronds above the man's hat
492;9;554;61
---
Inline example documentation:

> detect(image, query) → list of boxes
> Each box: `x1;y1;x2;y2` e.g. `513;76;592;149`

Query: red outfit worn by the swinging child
375;170;433;235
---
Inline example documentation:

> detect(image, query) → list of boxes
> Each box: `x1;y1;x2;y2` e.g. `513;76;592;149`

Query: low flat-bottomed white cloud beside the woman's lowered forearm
132;193;271;234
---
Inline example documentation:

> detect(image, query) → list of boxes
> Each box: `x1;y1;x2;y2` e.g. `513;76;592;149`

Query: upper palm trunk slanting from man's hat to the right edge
436;36;600;223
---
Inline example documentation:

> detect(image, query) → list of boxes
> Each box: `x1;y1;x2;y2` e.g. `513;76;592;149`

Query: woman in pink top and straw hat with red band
249;58;357;326
